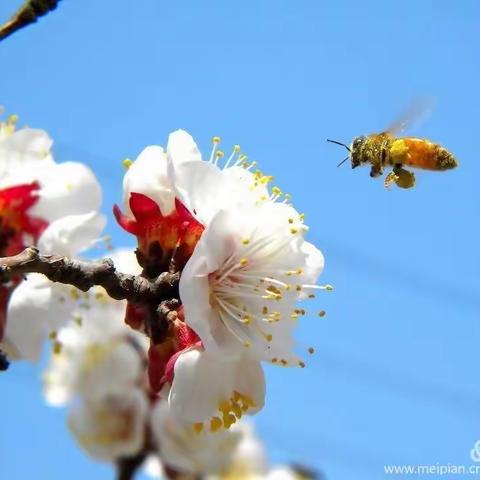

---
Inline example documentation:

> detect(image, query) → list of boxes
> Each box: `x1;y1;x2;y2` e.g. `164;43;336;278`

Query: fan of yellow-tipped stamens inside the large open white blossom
209;225;331;366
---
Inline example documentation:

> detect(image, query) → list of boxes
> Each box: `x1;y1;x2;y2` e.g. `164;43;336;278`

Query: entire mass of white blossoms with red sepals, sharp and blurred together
0;117;324;480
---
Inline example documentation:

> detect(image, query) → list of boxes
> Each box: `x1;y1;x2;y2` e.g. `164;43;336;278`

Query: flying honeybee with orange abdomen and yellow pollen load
327;104;458;188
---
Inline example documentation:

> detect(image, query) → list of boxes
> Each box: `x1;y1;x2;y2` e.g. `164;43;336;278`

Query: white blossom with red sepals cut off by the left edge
0;118;105;360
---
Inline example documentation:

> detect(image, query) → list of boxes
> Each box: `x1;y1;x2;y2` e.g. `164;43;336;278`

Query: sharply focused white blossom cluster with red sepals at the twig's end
115;130;329;433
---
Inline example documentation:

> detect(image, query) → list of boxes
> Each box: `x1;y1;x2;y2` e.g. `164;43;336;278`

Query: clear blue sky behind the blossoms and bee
0;0;480;480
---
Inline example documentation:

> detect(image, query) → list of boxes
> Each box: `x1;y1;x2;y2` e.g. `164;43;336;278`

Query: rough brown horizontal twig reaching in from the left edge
0;247;180;305
